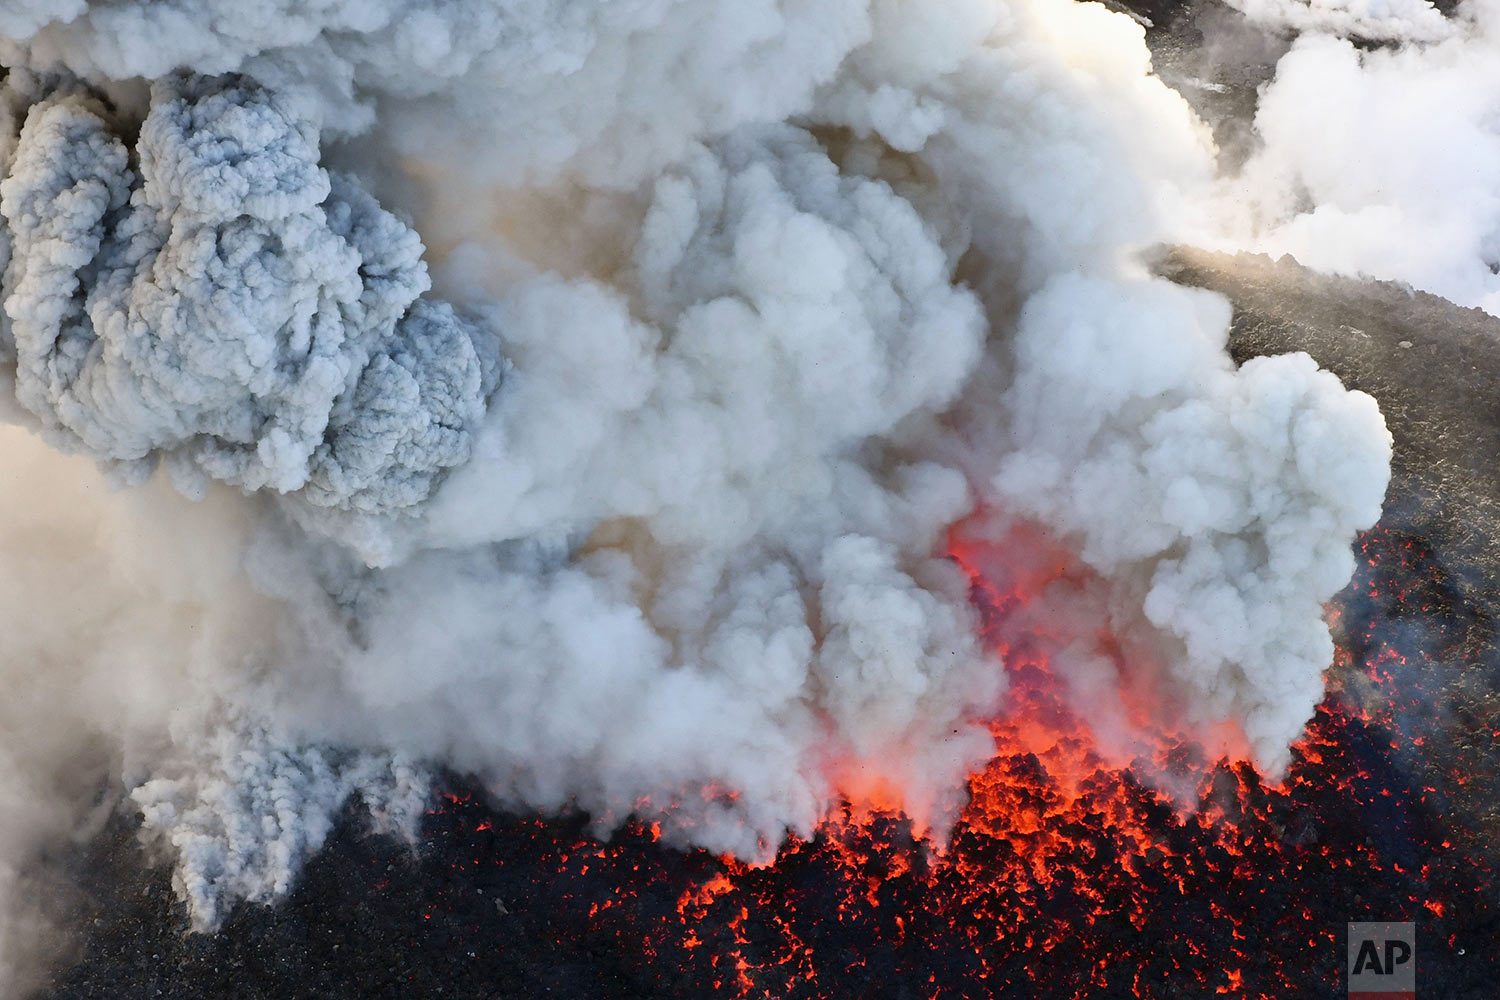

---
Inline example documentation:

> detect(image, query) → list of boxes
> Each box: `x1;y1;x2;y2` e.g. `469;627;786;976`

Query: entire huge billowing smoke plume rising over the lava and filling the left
0;0;1389;977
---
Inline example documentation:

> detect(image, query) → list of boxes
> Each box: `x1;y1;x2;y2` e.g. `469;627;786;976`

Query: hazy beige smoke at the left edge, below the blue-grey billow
0;427;284;982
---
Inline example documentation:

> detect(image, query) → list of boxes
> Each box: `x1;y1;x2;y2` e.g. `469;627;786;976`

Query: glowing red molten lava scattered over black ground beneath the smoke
414;521;1500;1000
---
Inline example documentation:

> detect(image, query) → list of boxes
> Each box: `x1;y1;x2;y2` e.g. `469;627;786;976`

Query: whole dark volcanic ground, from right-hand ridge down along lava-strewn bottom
36;250;1500;1000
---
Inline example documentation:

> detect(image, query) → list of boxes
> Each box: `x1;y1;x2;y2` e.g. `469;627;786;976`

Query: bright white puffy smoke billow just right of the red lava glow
995;276;1391;771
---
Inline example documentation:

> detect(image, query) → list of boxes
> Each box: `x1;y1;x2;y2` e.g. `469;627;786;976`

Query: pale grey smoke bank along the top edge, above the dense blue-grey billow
0;0;870;187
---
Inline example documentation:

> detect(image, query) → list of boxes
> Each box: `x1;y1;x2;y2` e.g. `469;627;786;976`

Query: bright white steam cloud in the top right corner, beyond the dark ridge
1230;0;1500;315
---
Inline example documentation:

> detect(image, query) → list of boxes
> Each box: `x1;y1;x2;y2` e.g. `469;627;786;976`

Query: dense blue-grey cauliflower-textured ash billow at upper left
0;78;500;524
